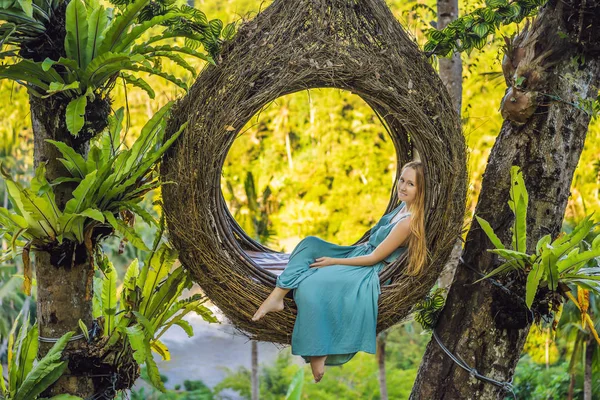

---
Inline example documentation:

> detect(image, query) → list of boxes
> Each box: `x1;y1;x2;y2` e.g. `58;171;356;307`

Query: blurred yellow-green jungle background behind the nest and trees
0;0;600;399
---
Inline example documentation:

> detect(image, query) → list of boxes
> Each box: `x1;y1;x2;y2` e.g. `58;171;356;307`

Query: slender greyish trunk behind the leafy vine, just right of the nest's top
437;0;462;115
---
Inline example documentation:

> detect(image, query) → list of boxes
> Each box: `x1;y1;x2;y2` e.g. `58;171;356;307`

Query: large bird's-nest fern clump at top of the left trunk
0;0;234;136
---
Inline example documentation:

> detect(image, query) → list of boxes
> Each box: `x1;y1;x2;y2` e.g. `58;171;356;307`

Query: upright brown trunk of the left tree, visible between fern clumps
30;98;94;398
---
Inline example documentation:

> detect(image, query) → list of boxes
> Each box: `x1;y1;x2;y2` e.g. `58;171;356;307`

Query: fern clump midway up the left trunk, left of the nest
0;102;185;260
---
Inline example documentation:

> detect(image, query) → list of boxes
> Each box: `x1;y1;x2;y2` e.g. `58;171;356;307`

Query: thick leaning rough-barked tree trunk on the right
411;0;600;400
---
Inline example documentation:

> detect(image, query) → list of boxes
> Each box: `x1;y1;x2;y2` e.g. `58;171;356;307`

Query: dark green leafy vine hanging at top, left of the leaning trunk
423;0;547;57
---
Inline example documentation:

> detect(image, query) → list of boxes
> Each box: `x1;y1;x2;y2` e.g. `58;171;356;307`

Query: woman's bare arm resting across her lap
310;216;411;268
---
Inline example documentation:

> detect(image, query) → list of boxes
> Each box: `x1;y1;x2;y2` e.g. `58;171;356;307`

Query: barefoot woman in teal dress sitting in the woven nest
252;161;427;382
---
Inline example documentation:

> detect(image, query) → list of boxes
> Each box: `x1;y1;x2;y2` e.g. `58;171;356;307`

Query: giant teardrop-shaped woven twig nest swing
161;0;467;344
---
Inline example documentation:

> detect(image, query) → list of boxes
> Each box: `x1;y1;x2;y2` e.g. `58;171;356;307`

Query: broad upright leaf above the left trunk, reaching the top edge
65;0;90;68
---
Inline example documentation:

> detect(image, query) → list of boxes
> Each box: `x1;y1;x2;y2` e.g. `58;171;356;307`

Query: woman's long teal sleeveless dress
276;202;409;365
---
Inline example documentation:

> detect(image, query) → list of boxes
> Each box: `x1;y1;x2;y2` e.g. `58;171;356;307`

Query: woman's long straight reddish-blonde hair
402;161;429;276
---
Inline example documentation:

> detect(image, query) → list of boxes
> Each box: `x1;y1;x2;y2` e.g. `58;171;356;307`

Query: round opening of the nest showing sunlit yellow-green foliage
221;89;397;253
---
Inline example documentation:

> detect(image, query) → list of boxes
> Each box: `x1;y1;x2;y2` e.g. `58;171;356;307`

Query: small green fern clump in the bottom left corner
0;314;80;400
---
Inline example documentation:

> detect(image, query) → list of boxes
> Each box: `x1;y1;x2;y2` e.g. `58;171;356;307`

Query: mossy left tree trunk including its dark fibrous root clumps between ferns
30;88;110;398
